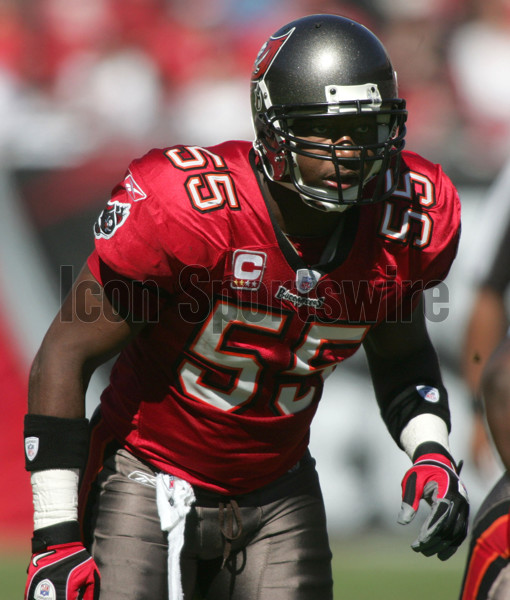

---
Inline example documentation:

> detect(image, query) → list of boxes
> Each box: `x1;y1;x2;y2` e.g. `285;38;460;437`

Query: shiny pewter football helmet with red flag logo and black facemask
251;15;407;210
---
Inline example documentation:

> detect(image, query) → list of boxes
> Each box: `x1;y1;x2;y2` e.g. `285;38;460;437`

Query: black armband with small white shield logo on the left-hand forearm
24;414;89;471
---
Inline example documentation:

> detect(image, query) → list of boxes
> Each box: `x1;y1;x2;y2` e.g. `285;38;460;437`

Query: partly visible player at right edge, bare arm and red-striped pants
460;337;510;600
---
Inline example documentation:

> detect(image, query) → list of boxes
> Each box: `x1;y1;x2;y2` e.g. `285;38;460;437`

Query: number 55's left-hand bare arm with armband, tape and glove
25;267;142;600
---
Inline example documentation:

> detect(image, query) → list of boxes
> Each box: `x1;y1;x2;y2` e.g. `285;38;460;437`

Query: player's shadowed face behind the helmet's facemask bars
292;115;377;195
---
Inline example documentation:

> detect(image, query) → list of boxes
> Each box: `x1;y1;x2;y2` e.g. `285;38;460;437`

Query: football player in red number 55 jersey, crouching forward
25;15;468;600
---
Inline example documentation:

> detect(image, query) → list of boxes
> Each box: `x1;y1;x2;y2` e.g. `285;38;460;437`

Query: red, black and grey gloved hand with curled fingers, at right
398;443;469;560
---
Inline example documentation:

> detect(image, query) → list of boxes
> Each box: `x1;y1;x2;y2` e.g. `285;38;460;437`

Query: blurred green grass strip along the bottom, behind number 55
0;535;467;600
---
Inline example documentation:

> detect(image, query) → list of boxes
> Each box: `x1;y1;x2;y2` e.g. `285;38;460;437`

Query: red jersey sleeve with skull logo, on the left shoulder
89;149;228;294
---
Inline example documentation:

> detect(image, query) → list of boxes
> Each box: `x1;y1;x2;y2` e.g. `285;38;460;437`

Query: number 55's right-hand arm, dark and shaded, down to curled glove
364;300;469;560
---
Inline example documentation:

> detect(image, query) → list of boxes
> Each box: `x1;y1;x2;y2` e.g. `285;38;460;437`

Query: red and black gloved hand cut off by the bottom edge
25;523;100;600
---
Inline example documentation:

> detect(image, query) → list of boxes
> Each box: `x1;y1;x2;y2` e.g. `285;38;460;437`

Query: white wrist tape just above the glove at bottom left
30;469;79;529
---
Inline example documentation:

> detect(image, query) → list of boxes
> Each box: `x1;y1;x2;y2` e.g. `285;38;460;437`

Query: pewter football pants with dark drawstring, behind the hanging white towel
86;450;333;600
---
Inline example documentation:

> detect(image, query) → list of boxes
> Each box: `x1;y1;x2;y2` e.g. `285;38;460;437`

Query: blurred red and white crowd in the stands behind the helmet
0;0;510;181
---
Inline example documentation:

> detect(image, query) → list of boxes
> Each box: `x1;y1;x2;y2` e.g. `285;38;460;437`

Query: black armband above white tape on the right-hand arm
381;384;451;448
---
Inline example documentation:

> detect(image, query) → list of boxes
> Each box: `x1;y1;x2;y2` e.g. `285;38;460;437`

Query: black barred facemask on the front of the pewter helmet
256;99;406;211
